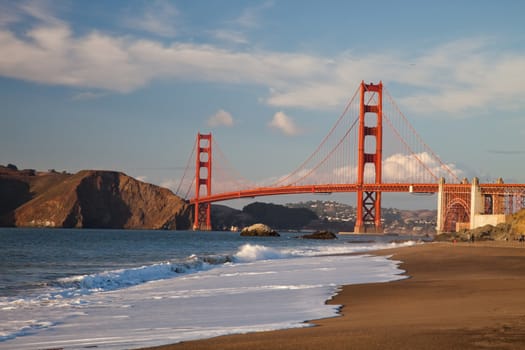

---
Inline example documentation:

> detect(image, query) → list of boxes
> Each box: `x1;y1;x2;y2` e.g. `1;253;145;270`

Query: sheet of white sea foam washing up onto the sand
0;245;410;349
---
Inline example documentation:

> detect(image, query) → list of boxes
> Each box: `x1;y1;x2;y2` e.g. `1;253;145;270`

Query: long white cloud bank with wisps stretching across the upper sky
0;5;525;117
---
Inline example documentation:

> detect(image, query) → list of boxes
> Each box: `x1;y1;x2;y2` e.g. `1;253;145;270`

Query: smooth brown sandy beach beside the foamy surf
142;242;525;350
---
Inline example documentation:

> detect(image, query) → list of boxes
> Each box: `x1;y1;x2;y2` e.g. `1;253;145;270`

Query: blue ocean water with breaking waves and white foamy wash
0;229;416;349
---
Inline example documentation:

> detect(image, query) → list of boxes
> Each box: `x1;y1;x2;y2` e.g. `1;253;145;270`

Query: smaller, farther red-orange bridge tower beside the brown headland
193;133;212;231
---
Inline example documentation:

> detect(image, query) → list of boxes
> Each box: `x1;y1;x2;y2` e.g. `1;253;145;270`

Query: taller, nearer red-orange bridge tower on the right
354;82;383;233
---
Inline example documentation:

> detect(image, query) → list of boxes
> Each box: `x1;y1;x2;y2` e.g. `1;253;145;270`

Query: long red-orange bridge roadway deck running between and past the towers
190;183;524;204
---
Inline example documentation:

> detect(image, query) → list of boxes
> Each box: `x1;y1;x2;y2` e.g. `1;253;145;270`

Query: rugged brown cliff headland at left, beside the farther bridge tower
0;170;190;230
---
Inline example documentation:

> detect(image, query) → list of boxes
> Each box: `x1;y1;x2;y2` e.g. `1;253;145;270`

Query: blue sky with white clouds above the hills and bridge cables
0;0;525;207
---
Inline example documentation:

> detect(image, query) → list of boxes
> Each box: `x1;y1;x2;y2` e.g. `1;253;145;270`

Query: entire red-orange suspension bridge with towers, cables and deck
177;82;525;233
